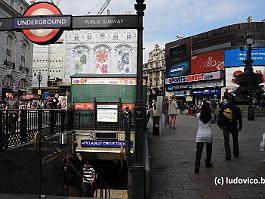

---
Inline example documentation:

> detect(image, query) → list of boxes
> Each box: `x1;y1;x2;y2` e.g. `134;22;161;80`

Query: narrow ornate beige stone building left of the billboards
143;44;166;94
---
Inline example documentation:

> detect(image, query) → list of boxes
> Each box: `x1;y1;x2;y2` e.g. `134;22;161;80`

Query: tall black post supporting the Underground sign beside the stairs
131;0;146;198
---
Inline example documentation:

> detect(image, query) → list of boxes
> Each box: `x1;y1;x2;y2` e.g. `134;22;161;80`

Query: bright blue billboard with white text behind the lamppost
224;48;265;67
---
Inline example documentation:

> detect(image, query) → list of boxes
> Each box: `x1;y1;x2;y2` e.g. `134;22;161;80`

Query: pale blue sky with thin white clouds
26;0;265;62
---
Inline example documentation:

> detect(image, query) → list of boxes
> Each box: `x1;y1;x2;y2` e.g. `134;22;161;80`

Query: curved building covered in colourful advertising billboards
165;22;265;104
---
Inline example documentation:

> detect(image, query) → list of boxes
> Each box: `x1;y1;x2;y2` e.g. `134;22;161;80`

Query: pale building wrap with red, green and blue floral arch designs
64;29;137;84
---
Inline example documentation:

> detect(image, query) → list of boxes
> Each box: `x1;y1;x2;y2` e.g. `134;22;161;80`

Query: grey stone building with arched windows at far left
0;0;32;99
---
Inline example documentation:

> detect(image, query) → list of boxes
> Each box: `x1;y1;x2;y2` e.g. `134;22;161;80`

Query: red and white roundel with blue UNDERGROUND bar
17;2;71;45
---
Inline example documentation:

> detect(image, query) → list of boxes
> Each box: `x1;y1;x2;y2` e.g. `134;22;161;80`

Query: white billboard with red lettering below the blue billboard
225;66;265;89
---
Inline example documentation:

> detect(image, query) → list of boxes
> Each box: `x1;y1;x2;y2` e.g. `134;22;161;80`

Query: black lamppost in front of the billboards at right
244;44;254;120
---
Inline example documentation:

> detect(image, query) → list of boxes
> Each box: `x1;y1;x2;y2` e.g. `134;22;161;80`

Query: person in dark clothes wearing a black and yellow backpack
217;95;242;160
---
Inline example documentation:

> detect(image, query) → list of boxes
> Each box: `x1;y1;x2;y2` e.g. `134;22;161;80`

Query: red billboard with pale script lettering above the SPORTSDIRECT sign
191;50;224;74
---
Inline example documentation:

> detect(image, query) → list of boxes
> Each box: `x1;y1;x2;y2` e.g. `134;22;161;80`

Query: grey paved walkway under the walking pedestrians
149;114;265;199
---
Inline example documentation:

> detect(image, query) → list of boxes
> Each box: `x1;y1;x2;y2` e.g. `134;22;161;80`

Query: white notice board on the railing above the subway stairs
97;104;118;122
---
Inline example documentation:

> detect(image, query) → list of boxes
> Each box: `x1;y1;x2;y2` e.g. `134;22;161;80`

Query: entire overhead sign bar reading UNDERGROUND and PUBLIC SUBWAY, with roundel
0;2;138;45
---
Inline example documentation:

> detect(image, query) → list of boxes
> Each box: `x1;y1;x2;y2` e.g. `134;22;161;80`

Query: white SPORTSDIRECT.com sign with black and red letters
165;71;223;84
